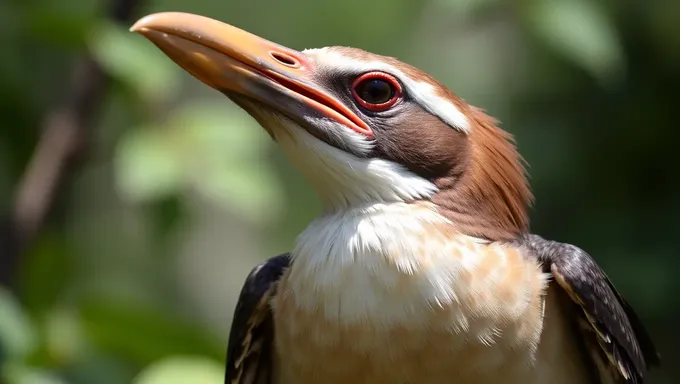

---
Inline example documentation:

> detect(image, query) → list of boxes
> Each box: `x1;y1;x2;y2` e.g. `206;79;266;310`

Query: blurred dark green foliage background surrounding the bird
0;0;680;384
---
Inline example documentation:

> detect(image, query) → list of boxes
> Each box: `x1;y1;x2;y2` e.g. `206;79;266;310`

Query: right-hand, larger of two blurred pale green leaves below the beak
174;103;282;220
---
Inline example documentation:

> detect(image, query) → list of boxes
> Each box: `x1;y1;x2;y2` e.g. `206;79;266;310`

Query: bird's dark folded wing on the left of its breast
224;253;290;384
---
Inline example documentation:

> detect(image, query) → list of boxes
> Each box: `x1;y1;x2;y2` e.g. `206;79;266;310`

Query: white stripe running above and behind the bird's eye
302;48;470;133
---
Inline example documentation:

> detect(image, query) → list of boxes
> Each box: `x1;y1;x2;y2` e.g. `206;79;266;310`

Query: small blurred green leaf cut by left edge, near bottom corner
0;287;37;360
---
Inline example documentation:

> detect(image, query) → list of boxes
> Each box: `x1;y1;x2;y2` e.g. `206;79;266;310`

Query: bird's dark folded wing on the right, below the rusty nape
521;235;660;384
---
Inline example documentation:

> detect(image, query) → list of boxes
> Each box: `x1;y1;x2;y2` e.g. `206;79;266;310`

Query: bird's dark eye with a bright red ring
352;72;401;111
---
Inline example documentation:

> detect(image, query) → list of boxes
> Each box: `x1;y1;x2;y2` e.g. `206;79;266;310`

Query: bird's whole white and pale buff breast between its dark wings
272;205;580;383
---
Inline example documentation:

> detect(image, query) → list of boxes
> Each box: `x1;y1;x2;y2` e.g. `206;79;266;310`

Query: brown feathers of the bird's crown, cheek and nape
333;48;533;241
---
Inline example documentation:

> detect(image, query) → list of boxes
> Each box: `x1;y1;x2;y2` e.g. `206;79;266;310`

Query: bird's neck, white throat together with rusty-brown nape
276;113;533;241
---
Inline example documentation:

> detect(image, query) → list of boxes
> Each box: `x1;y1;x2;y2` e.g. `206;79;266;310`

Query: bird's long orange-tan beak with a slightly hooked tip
131;12;372;136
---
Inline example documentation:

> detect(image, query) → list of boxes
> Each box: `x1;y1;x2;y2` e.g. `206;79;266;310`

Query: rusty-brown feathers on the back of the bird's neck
430;107;533;241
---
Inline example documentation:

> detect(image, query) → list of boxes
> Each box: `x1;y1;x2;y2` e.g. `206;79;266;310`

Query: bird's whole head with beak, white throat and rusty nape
132;13;532;240
